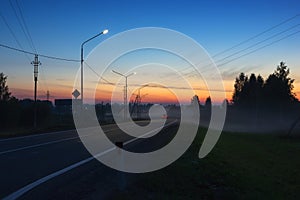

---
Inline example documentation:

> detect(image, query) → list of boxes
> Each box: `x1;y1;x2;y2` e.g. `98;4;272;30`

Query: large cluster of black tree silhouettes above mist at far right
232;62;297;109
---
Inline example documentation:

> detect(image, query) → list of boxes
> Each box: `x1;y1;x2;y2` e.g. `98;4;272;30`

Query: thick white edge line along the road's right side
3;120;177;200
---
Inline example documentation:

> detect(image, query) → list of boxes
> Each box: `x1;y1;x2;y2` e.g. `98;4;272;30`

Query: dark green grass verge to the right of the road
112;129;300;199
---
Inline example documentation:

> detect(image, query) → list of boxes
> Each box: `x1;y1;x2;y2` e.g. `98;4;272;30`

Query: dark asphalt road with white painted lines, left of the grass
0;120;178;199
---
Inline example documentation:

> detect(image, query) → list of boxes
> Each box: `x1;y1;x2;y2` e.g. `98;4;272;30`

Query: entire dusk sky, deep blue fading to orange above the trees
0;0;300;103
